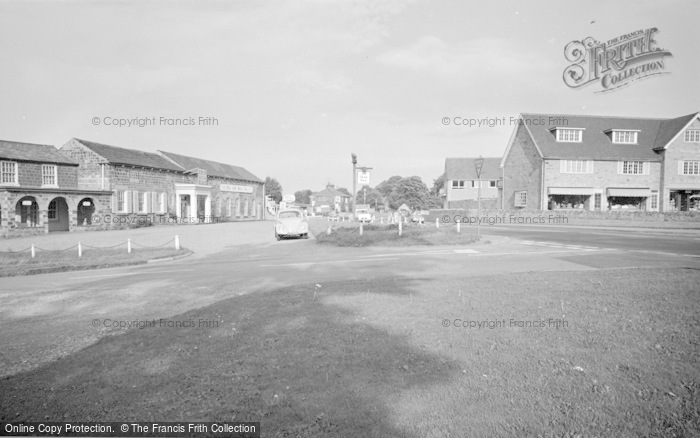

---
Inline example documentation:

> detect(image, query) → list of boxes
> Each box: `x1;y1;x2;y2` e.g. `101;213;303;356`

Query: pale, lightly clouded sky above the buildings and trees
0;0;700;193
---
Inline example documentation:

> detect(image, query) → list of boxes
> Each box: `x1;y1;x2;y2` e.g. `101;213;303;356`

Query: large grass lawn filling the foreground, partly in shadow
0;269;700;437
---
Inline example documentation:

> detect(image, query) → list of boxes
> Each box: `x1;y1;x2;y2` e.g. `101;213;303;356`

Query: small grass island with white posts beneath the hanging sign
310;222;478;246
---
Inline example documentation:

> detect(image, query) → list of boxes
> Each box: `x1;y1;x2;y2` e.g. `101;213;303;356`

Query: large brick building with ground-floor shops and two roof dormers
501;113;700;211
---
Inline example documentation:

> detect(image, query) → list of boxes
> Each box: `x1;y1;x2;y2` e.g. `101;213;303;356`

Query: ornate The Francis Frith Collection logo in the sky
564;27;673;93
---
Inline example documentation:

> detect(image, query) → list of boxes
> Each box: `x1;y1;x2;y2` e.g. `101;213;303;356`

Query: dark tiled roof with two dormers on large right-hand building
521;114;695;161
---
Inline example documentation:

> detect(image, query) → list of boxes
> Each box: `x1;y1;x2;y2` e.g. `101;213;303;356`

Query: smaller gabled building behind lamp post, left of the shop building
445;158;503;208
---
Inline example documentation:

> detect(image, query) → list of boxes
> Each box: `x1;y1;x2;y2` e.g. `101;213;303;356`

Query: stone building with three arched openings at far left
0;141;111;237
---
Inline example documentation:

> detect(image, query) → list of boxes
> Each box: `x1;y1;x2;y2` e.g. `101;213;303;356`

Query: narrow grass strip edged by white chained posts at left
0;248;188;277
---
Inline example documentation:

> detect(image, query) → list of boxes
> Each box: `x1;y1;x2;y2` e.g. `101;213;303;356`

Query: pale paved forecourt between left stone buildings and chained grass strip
0;221;273;257
